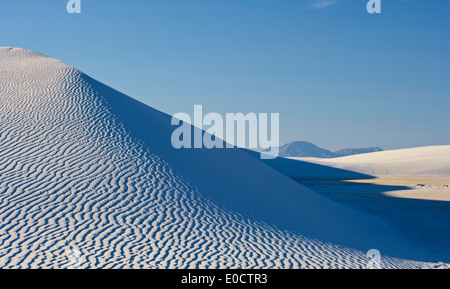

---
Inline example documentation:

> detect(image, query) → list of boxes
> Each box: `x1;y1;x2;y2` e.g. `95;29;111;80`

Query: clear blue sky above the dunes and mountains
0;0;450;149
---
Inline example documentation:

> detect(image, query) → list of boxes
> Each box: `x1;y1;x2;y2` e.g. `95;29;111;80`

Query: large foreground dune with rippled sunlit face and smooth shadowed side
0;48;439;268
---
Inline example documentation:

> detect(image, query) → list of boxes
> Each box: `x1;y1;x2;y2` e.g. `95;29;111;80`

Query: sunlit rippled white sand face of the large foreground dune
0;48;438;268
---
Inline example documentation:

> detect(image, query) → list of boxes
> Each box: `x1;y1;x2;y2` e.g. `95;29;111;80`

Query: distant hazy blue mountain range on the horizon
279;141;382;158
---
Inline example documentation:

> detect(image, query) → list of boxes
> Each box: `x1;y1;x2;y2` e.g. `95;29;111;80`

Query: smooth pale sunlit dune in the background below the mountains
288;145;450;178
